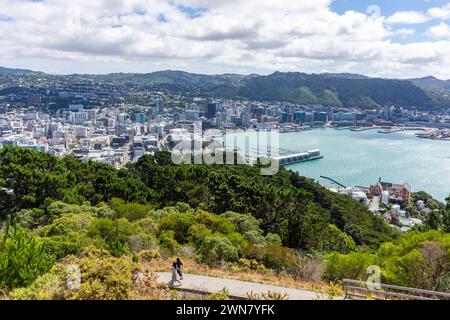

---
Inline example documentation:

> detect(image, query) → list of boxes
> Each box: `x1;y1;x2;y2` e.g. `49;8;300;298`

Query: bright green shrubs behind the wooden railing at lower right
325;231;450;291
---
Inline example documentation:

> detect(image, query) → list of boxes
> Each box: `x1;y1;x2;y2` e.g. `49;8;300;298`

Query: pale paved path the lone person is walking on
156;272;327;300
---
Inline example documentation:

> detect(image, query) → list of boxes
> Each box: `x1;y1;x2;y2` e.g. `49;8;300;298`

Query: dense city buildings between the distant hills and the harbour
0;85;450;167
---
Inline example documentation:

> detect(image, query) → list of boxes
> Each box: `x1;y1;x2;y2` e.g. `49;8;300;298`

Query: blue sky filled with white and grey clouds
0;0;450;79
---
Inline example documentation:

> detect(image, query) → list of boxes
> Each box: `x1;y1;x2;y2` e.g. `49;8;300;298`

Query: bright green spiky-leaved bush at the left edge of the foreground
0;226;54;289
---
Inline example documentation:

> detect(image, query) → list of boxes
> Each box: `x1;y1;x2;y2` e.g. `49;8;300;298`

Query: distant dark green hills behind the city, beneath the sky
0;68;450;110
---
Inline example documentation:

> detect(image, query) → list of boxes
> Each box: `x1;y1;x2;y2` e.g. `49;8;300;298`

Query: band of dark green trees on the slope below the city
0;147;393;249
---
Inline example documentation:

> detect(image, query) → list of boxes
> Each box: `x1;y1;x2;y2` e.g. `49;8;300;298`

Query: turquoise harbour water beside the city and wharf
227;128;450;201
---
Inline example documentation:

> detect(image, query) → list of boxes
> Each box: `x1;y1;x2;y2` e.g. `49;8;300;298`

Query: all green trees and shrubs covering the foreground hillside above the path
0;147;450;299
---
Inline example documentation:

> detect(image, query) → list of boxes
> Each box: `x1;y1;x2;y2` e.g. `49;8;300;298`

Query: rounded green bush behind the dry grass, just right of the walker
197;237;238;266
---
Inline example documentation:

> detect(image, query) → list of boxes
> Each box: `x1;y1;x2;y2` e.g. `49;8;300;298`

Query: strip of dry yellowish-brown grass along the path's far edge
145;258;343;296
